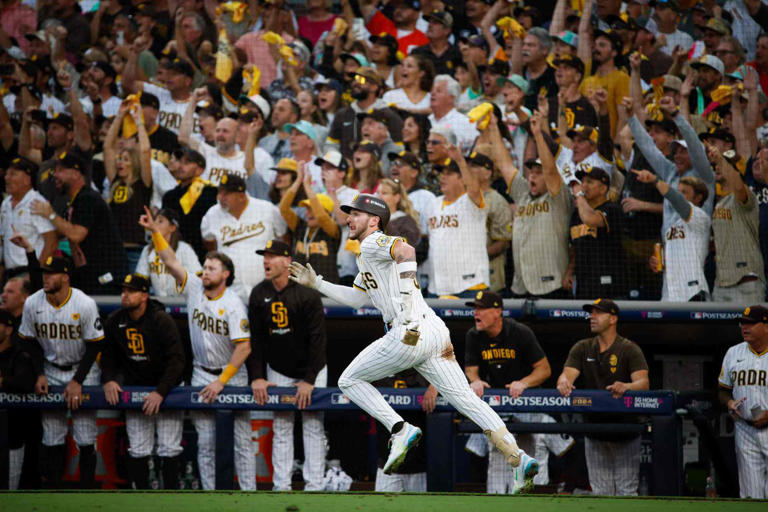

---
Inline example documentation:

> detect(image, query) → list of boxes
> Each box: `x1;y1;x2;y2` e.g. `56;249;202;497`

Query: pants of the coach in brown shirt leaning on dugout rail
584;436;641;496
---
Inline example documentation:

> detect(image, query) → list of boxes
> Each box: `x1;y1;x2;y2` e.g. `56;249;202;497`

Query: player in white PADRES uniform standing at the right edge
718;305;768;499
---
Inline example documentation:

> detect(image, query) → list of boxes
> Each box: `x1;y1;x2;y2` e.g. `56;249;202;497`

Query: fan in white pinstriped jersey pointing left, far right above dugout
632;169;712;302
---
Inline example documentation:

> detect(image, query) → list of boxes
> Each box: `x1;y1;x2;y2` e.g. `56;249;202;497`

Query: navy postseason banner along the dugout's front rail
0;386;675;415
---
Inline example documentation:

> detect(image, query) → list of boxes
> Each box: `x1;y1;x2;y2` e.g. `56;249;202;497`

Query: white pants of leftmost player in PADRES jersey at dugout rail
41;363;101;446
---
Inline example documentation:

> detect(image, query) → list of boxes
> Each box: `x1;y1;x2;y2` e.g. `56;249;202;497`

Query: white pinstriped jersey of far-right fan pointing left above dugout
661;204;712;302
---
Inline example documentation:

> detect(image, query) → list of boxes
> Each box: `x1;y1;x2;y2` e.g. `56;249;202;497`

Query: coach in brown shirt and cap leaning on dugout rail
557;299;648;496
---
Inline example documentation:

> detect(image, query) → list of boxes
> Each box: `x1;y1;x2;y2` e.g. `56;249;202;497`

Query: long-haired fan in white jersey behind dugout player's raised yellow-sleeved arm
136;208;203;297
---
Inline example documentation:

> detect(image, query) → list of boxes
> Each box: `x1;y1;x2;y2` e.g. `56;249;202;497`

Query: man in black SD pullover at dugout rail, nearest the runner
247;240;328;491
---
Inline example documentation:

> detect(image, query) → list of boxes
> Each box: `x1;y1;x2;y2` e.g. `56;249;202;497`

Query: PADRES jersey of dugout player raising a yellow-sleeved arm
179;272;251;368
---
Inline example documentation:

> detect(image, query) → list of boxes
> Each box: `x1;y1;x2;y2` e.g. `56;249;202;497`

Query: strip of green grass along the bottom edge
0;491;768;512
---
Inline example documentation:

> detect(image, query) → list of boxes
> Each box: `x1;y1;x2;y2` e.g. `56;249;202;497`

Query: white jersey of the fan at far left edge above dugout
0;190;56;269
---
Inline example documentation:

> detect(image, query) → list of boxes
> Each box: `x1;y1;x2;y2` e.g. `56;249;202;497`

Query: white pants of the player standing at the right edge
734;421;768;500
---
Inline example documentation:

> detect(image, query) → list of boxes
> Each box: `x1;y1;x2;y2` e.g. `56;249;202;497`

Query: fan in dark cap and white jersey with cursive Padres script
200;175;286;304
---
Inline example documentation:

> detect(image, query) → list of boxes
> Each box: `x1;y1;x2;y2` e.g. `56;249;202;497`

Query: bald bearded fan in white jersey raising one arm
179;87;246;187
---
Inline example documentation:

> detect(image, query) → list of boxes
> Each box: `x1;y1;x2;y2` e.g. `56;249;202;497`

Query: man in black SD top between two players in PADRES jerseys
101;274;184;489
